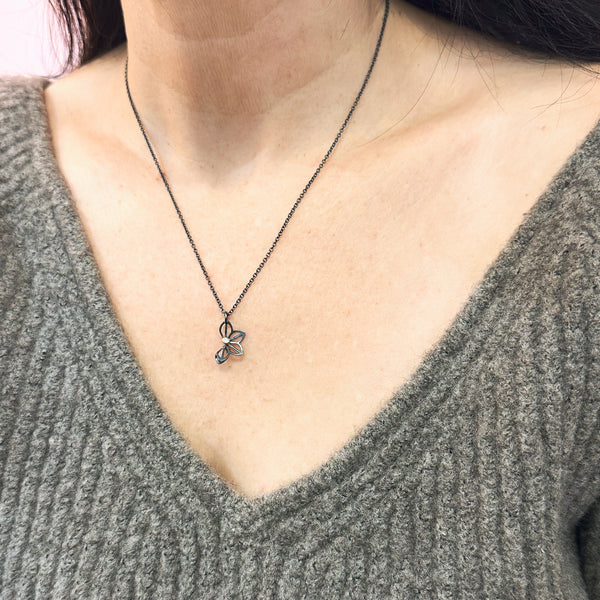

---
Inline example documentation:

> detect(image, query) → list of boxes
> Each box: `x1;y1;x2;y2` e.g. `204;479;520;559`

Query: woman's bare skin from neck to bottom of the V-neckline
46;0;600;498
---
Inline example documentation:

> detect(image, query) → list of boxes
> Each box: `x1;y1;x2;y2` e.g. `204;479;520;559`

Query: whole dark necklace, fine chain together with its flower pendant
125;0;390;365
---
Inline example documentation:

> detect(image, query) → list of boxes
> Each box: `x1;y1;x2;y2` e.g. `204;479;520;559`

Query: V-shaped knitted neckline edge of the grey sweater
25;78;600;532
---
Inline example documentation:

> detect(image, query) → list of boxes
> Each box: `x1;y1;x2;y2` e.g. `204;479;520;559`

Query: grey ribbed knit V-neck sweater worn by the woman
0;77;600;600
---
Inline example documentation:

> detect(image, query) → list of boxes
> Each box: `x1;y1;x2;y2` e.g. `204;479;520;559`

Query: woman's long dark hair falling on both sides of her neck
49;0;600;75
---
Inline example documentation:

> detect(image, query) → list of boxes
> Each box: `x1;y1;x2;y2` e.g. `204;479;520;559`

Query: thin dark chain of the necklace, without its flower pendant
125;0;390;317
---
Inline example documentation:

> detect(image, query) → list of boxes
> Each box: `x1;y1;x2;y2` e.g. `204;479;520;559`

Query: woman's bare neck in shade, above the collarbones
123;0;384;116
